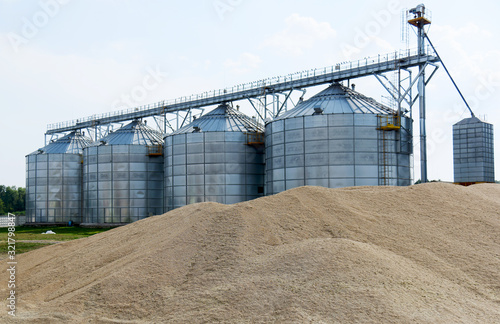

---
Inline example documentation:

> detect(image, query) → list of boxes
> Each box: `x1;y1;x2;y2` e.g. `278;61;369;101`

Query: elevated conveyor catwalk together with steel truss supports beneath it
45;49;439;140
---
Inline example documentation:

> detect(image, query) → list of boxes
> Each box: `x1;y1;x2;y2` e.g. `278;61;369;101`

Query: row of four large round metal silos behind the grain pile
27;84;412;224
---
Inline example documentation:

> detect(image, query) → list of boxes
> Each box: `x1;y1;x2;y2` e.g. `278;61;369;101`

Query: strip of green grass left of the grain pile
0;226;114;260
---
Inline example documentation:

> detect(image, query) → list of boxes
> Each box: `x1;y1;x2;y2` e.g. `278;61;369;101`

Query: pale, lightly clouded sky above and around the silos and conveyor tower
0;0;500;187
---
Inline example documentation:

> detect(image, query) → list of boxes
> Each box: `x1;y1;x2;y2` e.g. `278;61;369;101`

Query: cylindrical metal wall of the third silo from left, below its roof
165;132;264;211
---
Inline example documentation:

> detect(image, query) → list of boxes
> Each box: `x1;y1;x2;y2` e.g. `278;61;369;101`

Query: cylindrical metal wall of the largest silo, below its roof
266;114;412;194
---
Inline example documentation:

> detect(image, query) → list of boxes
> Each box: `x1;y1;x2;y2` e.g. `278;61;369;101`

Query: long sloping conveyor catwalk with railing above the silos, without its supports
46;50;438;135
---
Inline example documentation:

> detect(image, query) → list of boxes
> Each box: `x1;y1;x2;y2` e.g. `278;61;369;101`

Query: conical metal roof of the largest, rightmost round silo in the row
275;83;396;120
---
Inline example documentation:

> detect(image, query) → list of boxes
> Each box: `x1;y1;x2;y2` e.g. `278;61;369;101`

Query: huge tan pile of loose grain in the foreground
0;183;500;323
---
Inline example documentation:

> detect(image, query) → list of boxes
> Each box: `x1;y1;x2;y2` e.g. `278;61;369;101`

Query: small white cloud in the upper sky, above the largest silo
261;14;337;56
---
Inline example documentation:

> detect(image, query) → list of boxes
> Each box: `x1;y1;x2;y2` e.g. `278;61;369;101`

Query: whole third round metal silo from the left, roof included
165;104;264;210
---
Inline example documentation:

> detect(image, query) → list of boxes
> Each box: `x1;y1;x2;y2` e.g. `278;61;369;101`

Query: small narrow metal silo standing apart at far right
453;117;495;185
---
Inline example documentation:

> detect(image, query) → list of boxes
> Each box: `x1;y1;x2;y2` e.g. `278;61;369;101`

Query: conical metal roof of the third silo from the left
170;104;264;135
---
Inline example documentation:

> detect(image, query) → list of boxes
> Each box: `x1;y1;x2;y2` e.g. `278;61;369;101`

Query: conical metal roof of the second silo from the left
95;119;163;145
